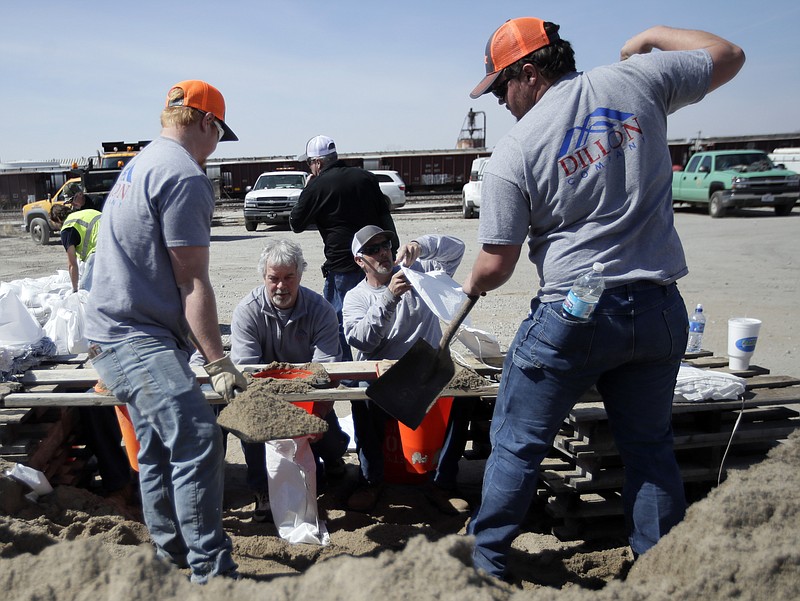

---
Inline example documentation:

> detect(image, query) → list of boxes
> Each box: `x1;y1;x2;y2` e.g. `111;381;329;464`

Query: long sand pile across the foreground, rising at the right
0;433;800;601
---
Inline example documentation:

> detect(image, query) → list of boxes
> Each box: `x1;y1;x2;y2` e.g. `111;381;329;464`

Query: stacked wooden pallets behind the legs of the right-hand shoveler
540;353;800;540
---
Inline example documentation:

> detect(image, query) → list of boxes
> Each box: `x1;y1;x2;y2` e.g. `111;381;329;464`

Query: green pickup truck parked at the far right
672;150;800;217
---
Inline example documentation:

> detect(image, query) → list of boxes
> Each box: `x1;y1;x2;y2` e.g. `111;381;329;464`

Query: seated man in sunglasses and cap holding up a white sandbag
342;226;472;514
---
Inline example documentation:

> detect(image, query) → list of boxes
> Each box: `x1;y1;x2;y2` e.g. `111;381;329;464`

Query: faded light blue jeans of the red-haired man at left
92;336;237;583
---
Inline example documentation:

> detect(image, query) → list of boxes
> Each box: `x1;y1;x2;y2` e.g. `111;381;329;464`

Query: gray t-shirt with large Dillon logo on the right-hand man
478;50;712;302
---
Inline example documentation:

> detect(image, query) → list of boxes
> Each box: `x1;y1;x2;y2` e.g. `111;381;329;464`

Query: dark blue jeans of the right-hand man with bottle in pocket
468;282;688;577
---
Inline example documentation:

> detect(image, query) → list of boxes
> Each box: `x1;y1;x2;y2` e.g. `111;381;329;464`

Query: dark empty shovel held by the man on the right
367;296;478;430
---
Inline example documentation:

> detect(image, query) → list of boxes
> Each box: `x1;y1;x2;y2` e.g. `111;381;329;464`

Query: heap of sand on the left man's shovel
217;378;328;442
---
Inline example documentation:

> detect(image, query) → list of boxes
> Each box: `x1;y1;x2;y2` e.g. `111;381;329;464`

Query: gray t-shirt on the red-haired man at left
86;137;214;350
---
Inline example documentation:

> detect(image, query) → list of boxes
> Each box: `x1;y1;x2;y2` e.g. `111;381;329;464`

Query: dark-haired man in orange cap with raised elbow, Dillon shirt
463;17;744;577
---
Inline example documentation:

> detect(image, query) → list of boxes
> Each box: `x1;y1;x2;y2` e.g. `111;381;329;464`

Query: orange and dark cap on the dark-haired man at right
469;17;558;98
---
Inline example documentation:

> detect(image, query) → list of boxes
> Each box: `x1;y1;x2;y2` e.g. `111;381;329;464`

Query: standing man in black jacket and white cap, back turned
289;135;397;361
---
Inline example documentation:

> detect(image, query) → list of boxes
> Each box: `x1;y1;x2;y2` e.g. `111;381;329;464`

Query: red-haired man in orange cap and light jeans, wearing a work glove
86;80;247;583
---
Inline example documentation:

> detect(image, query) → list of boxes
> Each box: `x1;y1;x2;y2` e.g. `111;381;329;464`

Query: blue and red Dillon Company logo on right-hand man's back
558;107;643;177
